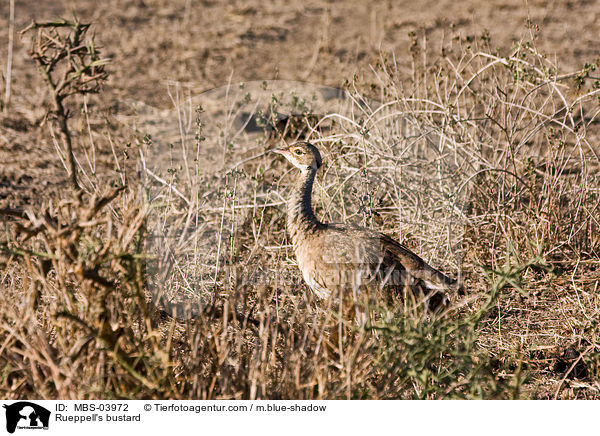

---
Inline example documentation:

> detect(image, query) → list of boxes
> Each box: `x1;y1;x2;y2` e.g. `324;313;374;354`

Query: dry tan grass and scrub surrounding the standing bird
0;19;600;399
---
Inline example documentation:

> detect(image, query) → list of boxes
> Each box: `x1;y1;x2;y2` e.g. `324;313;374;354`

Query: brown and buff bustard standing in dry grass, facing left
274;142;461;308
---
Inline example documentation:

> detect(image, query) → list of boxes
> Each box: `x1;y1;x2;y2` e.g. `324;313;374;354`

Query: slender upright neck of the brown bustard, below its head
287;168;323;243
